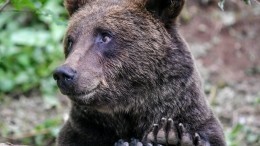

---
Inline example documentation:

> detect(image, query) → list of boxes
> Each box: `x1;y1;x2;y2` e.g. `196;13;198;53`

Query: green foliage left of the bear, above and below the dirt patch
0;0;67;146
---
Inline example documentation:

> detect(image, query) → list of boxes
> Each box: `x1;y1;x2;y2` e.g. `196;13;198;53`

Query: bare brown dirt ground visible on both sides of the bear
0;0;260;146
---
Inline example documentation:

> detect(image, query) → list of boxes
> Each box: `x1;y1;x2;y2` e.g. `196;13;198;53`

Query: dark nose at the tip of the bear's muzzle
53;66;76;82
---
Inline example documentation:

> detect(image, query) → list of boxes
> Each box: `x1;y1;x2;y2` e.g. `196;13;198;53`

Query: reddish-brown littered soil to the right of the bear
180;1;260;146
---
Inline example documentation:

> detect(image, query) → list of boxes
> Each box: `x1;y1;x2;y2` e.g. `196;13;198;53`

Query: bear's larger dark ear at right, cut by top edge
145;0;185;25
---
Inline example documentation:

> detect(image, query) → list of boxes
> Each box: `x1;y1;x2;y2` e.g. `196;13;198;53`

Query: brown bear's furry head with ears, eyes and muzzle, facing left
54;0;192;112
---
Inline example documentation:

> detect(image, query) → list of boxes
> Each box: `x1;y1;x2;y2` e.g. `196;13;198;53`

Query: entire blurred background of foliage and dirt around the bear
0;0;260;146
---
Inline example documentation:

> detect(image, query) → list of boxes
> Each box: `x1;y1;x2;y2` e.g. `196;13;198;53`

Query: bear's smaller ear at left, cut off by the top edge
64;0;91;16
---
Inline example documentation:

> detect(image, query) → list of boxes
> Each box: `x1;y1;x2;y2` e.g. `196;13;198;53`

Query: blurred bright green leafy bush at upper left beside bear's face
0;0;66;93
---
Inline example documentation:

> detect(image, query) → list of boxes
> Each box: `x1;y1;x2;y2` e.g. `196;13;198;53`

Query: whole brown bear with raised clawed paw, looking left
53;0;225;146
